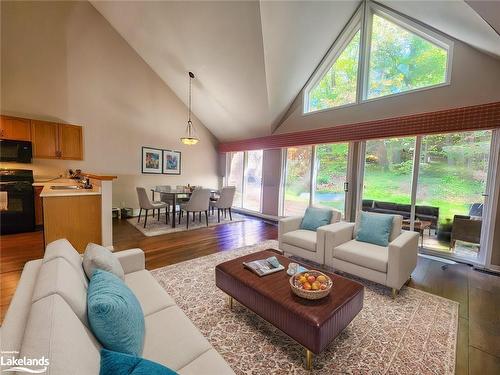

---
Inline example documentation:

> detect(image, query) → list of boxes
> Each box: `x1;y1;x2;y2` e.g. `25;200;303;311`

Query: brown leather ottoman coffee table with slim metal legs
215;250;364;369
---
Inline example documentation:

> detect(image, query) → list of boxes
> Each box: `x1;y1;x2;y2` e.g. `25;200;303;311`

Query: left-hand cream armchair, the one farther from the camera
278;209;341;264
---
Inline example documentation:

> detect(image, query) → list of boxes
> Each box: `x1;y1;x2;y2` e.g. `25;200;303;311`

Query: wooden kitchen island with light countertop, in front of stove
34;174;116;252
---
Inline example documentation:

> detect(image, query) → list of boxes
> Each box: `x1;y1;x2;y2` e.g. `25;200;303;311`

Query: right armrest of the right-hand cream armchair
387;231;419;289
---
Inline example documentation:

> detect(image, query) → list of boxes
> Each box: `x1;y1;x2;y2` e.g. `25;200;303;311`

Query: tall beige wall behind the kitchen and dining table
0;1;218;207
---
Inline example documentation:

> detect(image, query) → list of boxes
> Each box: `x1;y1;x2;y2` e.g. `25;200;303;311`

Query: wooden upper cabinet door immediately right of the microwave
31;120;59;159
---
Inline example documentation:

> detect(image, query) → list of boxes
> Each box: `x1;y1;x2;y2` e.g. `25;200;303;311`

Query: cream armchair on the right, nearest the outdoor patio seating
325;215;418;296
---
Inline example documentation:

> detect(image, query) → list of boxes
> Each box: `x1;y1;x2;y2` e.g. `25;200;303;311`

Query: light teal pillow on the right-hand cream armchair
356;212;394;246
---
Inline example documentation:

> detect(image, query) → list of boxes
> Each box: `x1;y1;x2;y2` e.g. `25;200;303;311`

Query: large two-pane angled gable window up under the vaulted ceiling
304;1;453;113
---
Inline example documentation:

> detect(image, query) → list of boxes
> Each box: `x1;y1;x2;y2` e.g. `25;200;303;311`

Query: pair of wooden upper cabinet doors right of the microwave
31;120;83;160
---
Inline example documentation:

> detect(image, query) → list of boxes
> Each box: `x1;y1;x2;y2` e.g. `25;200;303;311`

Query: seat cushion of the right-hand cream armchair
333;240;389;273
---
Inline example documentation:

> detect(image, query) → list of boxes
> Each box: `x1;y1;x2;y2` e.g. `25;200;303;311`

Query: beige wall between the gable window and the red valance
275;41;500;134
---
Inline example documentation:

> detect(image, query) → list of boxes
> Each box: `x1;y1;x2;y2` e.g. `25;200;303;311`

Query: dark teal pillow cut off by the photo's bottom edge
99;349;177;375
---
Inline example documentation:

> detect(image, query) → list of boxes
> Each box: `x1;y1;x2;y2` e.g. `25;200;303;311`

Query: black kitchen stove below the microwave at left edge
0;169;35;234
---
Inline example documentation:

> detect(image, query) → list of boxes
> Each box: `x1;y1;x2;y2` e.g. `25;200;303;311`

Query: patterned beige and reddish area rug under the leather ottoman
152;241;458;375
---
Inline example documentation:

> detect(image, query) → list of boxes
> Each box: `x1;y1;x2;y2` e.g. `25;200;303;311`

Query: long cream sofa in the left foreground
1;240;234;375
